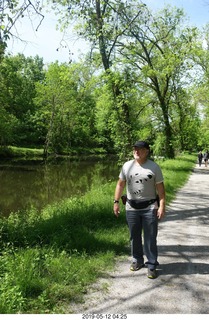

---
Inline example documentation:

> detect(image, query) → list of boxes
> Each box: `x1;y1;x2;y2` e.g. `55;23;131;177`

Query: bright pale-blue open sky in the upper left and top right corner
7;0;209;63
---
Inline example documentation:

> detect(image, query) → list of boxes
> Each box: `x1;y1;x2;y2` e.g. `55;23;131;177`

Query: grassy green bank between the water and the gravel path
0;155;196;314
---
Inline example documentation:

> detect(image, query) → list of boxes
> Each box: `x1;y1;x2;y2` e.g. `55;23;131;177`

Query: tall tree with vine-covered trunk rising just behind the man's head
49;0;149;156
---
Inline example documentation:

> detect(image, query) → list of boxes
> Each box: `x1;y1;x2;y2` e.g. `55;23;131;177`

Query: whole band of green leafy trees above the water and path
0;0;208;159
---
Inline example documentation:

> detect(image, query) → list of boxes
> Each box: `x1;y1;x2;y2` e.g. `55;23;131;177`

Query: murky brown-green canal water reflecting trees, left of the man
0;161;119;215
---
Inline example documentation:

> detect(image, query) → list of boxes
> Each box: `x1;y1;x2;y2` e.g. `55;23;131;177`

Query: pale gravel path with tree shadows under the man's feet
72;165;209;314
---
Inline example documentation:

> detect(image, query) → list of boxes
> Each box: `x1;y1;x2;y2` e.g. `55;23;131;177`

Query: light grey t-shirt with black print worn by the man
119;159;163;210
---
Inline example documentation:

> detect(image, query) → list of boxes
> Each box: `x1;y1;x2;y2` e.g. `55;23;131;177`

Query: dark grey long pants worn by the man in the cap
126;209;159;269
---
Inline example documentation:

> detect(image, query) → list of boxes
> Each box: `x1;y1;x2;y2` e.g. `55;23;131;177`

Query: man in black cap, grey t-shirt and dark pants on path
113;141;165;279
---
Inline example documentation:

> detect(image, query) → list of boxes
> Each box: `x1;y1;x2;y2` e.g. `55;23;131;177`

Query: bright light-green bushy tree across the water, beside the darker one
34;62;97;156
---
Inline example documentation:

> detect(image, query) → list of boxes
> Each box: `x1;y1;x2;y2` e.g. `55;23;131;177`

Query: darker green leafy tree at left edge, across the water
0;54;44;145
